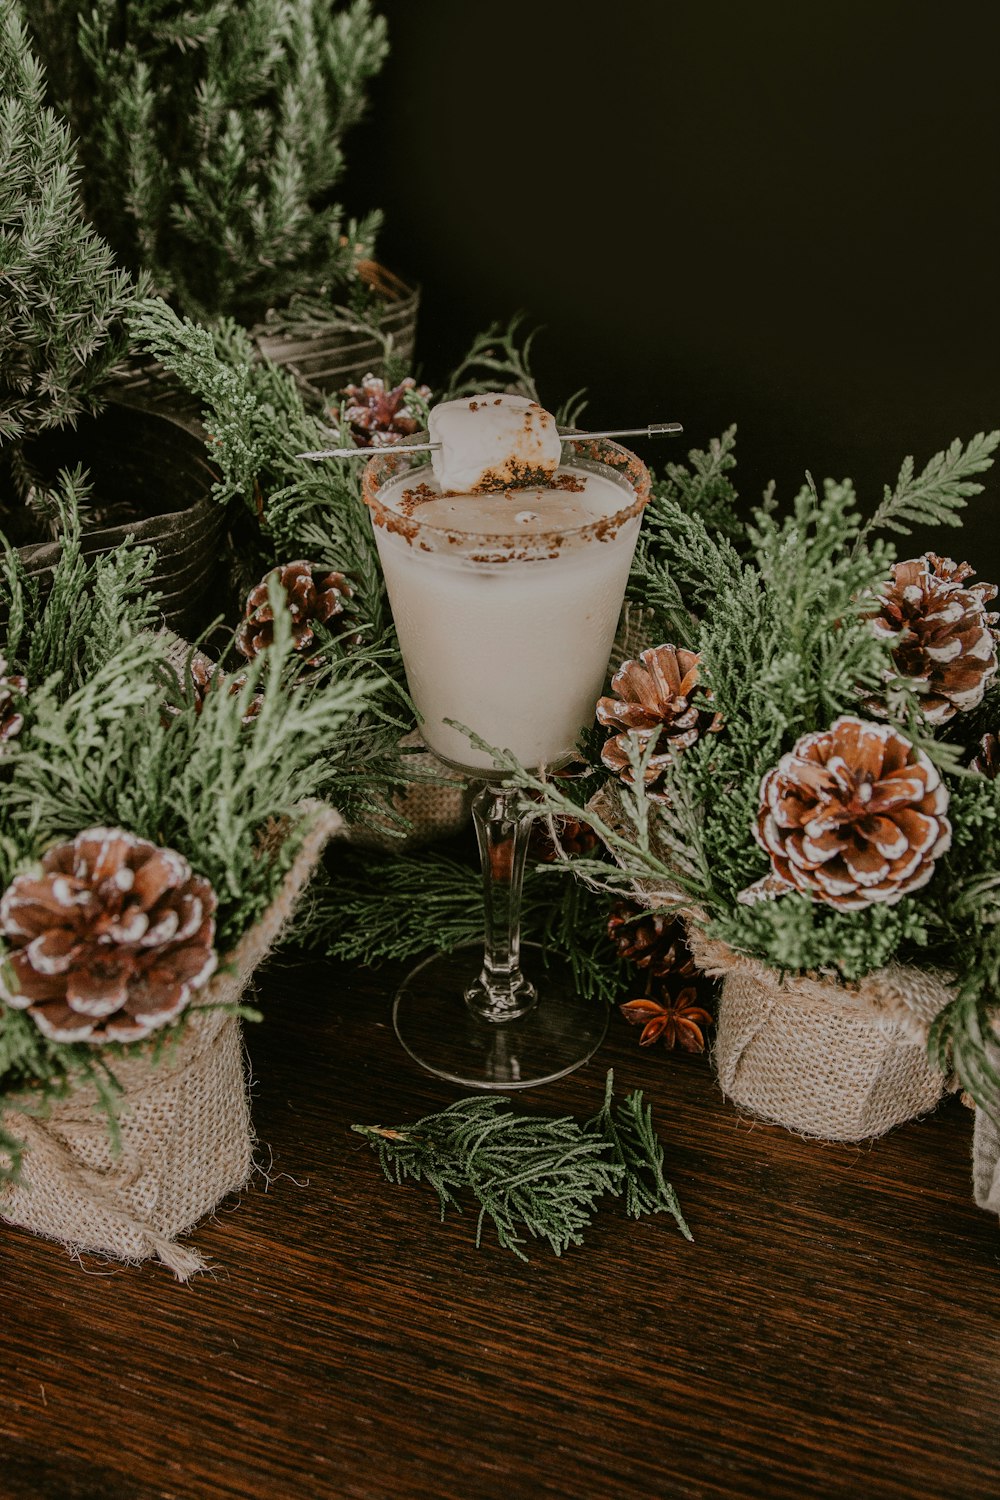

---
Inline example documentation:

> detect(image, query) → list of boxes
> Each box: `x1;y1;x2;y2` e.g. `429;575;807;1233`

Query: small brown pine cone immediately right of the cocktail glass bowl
597;645;721;801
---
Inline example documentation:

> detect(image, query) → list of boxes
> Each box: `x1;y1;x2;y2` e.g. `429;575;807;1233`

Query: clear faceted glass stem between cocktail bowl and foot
465;783;537;1023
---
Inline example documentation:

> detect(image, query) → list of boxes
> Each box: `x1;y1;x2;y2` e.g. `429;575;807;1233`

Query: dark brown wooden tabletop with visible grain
0;962;1000;1500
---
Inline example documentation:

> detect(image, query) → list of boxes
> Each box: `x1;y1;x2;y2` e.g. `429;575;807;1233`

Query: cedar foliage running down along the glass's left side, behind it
130;299;414;831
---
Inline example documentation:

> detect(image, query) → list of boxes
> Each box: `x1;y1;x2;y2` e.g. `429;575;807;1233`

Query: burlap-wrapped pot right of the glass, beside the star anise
690;926;951;1140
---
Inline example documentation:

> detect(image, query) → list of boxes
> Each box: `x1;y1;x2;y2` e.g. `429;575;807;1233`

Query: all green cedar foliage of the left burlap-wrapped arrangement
0;510;383;1175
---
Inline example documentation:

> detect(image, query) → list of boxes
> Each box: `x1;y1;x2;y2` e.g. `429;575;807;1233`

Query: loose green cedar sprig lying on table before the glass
351;1071;693;1260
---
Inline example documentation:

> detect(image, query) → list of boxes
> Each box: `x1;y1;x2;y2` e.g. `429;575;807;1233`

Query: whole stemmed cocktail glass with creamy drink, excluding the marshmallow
363;438;649;1089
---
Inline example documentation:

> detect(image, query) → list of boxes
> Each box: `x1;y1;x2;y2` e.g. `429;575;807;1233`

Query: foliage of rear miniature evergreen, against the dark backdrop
30;0;387;326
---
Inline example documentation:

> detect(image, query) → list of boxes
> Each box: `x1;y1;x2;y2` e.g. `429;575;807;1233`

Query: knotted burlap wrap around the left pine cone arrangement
0;803;342;1281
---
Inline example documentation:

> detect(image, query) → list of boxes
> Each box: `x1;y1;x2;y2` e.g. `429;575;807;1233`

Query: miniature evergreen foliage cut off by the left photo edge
0;5;135;446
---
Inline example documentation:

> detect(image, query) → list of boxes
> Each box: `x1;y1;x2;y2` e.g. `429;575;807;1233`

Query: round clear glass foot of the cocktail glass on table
393;944;607;1091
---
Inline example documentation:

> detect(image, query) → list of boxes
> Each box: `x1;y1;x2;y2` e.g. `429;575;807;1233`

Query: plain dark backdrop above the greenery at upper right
343;0;1000;576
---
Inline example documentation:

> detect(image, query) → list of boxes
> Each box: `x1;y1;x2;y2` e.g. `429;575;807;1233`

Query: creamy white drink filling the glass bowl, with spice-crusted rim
369;450;645;771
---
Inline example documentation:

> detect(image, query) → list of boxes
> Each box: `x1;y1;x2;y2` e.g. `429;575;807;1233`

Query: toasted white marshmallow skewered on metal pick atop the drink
429;392;561;495
